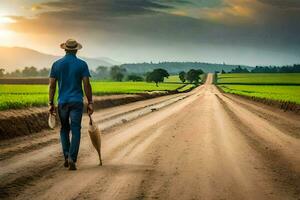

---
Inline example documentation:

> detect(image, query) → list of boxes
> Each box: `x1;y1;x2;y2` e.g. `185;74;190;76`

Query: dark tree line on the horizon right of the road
222;64;300;74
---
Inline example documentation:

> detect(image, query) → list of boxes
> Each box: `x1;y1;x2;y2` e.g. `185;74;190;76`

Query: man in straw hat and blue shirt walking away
49;39;94;170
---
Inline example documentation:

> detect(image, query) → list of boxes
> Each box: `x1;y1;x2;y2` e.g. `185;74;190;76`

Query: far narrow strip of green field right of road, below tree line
218;73;300;85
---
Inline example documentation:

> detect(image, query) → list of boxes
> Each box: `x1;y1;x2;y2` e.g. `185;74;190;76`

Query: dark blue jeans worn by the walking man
58;102;83;162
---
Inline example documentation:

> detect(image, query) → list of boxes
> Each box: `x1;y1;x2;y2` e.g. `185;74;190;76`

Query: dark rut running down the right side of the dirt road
217;92;300;199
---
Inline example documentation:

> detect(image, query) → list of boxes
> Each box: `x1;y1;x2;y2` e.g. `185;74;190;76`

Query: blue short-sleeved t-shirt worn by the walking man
50;54;91;104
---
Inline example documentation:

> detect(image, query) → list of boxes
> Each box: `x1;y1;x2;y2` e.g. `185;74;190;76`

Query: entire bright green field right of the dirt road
218;74;300;104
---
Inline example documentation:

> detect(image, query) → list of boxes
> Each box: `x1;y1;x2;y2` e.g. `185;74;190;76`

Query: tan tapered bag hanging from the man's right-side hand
88;115;102;166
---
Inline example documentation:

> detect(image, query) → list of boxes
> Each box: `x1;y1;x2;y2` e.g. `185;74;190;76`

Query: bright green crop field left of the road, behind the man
0;81;185;110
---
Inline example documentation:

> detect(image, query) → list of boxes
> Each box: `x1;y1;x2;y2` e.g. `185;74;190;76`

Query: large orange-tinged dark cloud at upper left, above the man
10;0;192;34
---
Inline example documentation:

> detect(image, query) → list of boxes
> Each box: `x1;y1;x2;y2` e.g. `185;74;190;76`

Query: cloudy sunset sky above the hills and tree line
0;0;300;66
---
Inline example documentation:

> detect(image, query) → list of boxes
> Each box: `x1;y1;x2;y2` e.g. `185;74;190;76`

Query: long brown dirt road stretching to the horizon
0;75;300;200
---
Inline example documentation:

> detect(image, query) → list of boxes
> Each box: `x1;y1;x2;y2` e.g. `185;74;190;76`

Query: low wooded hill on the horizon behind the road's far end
122;62;253;74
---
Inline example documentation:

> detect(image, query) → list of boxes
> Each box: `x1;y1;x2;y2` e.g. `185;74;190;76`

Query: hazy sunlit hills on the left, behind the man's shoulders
0;47;115;71
